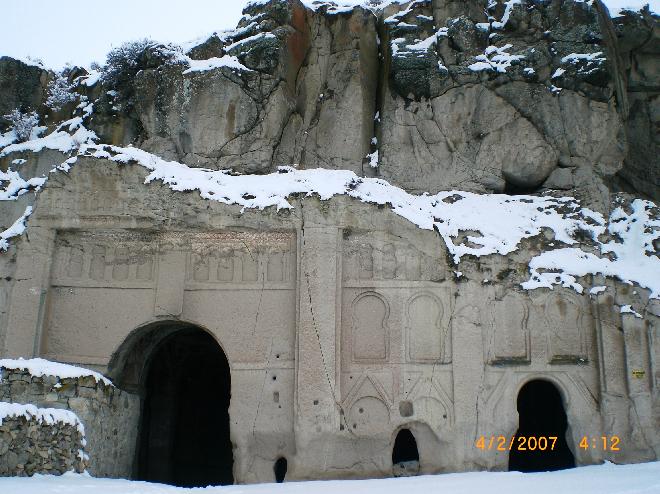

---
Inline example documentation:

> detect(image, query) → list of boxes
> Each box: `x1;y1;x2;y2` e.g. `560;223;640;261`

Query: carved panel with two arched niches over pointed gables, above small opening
340;280;453;435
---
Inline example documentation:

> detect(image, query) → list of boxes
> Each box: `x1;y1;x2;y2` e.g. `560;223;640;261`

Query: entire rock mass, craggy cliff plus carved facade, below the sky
0;0;660;486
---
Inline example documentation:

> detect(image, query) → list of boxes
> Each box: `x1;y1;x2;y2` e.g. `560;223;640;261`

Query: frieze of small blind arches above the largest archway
52;231;295;289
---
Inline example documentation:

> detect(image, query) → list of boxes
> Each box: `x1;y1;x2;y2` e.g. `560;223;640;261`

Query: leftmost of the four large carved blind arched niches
351;291;390;362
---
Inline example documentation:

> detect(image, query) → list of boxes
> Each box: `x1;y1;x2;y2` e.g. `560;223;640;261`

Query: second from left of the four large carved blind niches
406;293;451;363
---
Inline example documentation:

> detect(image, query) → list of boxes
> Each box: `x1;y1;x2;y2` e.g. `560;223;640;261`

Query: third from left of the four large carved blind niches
486;293;530;365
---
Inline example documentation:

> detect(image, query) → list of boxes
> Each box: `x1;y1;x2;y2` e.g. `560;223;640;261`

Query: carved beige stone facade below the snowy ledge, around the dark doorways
0;158;660;483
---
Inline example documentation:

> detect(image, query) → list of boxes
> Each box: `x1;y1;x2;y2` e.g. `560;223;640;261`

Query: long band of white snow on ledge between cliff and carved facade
0;124;660;306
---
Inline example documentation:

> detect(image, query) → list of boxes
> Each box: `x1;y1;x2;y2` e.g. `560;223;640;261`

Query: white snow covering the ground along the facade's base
0;462;660;494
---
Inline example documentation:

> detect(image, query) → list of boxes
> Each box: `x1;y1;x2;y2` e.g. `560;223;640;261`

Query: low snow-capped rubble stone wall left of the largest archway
0;368;139;477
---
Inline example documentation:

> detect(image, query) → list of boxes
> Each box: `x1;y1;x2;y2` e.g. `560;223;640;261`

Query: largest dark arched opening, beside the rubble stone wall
137;327;234;487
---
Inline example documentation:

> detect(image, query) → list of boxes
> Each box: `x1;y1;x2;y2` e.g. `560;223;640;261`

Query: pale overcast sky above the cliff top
0;0;660;69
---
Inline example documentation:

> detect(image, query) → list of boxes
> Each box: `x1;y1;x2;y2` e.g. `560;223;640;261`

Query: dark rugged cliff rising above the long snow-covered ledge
0;0;660;205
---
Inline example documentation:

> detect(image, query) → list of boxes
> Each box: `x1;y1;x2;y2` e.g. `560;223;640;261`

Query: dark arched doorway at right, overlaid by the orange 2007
509;379;575;472
